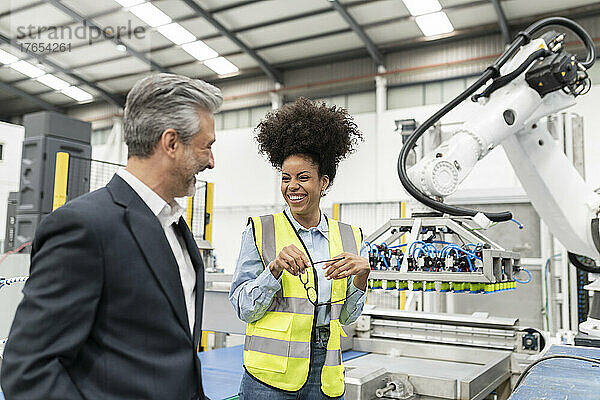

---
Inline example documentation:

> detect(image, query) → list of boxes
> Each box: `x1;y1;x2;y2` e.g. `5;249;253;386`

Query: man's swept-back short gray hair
123;74;223;157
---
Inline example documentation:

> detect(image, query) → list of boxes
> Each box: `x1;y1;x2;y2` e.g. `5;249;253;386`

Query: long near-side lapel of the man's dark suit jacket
107;175;192;340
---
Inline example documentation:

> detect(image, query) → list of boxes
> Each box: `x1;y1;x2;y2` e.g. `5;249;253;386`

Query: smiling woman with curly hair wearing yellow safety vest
229;98;370;400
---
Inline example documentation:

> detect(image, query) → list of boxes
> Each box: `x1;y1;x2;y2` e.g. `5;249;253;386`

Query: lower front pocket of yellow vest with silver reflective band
245;312;293;373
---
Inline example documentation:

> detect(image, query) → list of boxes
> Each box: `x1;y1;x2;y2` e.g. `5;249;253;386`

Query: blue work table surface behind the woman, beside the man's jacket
0;345;367;400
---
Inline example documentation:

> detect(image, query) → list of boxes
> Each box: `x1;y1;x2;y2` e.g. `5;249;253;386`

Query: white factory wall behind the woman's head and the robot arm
203;104;524;273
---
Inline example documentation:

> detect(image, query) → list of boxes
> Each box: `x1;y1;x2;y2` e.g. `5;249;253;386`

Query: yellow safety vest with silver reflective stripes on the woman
244;212;362;397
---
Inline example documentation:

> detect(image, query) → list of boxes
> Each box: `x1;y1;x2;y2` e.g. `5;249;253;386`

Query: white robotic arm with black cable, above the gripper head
398;18;600;259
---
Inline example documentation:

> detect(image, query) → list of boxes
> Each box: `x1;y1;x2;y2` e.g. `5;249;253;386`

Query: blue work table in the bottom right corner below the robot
509;345;600;400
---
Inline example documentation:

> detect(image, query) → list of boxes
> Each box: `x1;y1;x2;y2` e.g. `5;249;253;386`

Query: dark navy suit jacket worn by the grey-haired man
0;175;204;400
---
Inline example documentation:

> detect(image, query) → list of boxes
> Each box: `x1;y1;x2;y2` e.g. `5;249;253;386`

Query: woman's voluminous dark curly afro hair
254;97;363;187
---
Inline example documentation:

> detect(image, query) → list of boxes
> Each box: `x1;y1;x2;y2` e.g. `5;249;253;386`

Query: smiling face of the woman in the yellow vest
281;154;329;220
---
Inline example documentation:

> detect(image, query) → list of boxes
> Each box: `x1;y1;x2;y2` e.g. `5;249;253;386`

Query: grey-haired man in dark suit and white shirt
1;74;222;400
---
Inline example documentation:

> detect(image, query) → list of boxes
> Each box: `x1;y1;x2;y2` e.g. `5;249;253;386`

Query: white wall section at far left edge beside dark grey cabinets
0;122;25;247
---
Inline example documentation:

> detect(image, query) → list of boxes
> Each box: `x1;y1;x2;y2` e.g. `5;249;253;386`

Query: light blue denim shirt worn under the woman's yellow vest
229;207;368;326
